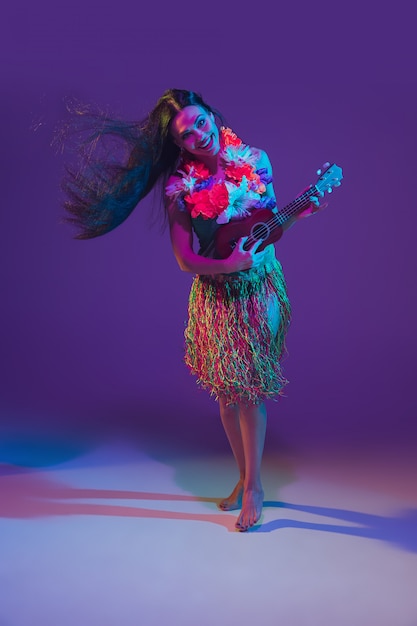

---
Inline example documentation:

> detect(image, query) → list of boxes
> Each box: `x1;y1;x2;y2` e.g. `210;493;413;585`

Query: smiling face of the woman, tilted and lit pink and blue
171;104;220;158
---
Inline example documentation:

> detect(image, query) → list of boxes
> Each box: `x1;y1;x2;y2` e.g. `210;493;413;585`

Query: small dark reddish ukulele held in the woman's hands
204;163;343;259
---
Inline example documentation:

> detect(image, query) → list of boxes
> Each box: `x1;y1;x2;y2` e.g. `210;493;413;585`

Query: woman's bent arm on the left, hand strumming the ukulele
167;196;265;275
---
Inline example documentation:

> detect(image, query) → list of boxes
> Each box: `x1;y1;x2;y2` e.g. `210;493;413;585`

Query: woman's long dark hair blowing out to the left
58;89;224;239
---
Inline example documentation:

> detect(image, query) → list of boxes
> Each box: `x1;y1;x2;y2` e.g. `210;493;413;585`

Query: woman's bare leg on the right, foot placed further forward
236;404;267;530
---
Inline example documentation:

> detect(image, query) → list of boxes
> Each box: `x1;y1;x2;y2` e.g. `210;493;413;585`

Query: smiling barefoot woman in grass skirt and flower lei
64;89;318;531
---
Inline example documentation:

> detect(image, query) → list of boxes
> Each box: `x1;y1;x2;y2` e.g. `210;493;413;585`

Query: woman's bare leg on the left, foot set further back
218;397;245;511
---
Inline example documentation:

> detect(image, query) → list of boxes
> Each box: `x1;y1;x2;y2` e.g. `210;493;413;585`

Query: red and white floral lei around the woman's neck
165;127;276;224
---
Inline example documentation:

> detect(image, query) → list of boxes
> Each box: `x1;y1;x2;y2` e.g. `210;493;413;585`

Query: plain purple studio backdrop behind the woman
0;0;417;458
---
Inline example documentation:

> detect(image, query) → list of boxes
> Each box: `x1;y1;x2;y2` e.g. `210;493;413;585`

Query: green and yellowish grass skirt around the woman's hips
185;258;291;404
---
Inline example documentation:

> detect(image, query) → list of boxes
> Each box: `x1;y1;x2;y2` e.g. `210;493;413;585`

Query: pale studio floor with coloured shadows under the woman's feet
0;439;417;626
